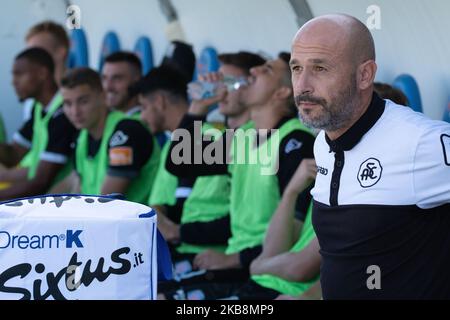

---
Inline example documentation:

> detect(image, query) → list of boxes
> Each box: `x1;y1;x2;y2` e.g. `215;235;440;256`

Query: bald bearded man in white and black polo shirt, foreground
290;15;450;299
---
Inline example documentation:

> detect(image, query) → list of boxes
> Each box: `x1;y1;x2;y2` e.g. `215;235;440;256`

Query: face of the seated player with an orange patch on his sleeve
61;84;105;130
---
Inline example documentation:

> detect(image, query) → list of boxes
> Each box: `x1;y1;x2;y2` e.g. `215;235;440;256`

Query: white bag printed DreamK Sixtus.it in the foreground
0;195;158;300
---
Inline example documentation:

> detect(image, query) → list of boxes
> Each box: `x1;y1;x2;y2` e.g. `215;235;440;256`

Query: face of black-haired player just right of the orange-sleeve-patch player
139;92;167;134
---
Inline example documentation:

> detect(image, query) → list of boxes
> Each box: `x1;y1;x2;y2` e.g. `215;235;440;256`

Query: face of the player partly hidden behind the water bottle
219;64;247;117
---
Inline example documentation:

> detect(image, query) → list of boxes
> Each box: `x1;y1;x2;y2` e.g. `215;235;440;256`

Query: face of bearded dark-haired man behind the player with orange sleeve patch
102;62;139;110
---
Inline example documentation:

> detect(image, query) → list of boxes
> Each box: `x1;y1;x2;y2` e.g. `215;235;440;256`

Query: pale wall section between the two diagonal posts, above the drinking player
172;0;297;56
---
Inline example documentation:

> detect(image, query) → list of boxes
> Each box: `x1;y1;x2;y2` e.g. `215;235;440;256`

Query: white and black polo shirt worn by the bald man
311;94;450;299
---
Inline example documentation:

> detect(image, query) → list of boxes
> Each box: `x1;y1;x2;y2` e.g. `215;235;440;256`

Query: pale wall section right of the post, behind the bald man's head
309;0;450;119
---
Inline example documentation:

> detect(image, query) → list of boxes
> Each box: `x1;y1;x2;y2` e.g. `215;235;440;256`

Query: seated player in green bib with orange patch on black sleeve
61;68;160;204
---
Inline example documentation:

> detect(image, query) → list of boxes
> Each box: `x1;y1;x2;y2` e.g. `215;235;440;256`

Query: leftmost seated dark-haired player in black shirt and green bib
0;48;76;200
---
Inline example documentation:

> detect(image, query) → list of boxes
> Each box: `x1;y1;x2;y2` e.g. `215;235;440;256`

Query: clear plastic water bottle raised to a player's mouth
188;76;248;100
